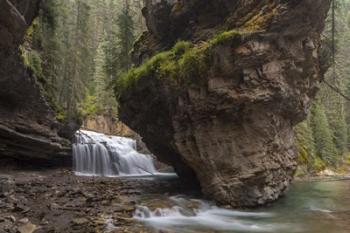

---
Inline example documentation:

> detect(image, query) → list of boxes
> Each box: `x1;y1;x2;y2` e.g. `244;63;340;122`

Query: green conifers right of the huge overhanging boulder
297;0;350;173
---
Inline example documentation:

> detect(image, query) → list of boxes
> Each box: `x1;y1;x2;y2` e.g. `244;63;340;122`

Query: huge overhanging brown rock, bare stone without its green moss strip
119;0;330;207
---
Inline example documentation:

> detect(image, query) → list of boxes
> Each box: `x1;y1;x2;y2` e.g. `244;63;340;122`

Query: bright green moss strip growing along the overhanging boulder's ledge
115;30;240;98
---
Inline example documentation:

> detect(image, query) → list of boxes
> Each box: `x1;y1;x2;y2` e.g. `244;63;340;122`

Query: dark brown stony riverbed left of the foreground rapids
0;169;190;233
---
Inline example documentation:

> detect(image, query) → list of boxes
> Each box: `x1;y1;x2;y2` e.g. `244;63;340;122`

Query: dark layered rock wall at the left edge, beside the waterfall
0;0;75;161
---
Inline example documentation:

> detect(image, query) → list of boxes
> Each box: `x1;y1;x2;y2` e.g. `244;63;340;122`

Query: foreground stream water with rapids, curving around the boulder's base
134;181;350;233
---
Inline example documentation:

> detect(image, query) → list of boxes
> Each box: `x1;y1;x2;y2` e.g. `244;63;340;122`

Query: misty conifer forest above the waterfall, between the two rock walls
22;0;145;124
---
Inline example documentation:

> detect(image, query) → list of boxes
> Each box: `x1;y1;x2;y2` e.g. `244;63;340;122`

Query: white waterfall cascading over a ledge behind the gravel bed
73;130;157;176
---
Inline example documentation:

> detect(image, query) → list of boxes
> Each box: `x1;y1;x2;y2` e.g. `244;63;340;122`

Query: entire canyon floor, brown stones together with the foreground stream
0;168;350;233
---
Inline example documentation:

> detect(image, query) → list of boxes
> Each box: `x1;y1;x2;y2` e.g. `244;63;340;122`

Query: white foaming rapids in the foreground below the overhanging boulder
134;197;292;233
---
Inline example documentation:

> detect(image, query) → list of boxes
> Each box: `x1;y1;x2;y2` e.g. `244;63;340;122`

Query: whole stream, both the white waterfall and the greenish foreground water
73;131;350;233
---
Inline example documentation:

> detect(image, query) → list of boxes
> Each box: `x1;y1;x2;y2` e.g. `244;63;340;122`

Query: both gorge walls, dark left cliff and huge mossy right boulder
0;0;331;217
